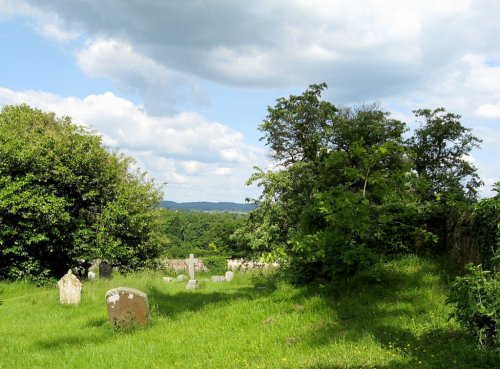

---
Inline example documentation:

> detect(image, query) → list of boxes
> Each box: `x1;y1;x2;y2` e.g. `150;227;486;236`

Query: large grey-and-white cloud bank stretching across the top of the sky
8;0;500;103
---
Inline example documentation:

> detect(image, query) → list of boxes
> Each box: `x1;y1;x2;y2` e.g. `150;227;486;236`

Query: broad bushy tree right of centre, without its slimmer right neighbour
247;84;413;282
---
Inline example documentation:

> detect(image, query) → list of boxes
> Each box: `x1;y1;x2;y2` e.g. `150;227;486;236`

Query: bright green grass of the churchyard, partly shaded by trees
0;257;500;369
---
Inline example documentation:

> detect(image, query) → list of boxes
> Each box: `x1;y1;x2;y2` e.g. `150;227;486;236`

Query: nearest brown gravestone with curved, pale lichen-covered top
106;287;149;328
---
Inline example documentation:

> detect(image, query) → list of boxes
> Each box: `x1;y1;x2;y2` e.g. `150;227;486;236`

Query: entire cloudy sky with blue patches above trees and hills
0;0;500;202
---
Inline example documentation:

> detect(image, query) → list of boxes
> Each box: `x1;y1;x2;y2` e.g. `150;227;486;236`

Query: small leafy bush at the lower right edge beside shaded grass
447;255;500;349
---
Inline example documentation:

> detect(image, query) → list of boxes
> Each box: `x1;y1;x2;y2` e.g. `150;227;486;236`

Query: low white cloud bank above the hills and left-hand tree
0;88;264;201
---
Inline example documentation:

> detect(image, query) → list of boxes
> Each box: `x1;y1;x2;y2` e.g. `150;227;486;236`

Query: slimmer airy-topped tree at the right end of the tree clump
408;108;482;252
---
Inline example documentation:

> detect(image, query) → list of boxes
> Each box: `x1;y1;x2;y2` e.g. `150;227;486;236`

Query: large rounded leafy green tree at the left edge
0;105;165;278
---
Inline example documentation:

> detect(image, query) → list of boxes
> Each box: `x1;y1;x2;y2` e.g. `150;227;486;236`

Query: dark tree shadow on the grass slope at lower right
298;256;500;369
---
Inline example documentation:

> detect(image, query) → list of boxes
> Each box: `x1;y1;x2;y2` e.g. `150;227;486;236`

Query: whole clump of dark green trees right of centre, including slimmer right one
244;84;480;282
